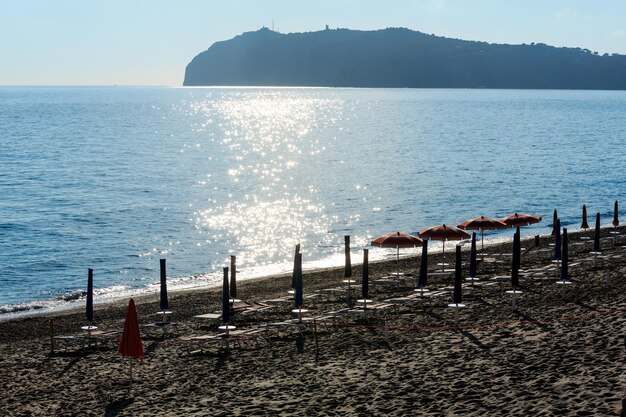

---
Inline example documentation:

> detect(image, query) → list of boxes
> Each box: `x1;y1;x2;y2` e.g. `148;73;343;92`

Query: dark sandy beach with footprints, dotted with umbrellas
0;228;626;416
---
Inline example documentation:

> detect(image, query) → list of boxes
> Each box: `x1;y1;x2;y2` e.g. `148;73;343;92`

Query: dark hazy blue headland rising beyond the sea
183;28;626;90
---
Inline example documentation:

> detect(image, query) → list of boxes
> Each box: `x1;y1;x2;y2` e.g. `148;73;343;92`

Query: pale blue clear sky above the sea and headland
0;0;626;86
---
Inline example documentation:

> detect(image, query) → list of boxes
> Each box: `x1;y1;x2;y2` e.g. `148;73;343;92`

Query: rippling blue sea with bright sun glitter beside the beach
0;86;626;318
